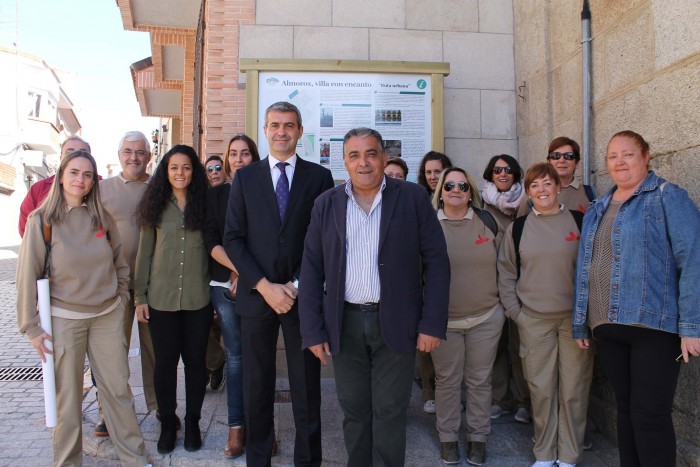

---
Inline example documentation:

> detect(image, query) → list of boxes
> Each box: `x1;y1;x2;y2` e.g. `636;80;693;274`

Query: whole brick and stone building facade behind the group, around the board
117;0;700;465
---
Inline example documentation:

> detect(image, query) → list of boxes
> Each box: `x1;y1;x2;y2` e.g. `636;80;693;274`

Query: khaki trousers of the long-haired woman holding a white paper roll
51;305;148;466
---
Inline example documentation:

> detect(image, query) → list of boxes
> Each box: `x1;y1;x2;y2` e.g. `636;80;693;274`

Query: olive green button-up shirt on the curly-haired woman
134;198;209;311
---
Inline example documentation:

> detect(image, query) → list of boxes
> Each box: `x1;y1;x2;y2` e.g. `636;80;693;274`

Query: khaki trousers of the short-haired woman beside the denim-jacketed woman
516;312;593;464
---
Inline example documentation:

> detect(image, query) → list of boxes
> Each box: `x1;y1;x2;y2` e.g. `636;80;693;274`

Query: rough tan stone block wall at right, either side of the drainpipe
513;0;700;466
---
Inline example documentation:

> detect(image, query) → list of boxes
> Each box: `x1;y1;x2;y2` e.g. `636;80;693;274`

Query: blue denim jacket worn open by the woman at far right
572;172;700;339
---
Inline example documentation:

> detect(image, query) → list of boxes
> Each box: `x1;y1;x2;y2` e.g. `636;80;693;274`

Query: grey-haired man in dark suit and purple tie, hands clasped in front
224;102;333;466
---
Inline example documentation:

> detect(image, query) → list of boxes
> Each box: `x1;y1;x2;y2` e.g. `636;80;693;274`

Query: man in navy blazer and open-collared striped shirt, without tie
299;128;450;467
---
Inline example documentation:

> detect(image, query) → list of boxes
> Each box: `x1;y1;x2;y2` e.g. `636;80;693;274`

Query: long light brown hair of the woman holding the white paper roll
31;150;113;232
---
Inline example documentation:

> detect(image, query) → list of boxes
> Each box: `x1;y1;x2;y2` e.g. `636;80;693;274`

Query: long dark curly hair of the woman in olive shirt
136;144;209;230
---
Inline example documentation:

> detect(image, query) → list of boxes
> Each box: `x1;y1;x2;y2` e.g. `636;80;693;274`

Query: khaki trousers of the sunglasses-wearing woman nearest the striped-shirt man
431;307;505;443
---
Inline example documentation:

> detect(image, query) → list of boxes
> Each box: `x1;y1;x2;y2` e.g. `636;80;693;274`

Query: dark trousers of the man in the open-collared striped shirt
333;306;416;467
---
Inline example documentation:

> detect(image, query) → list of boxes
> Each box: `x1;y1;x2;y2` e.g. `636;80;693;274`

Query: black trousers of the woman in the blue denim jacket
594;324;680;467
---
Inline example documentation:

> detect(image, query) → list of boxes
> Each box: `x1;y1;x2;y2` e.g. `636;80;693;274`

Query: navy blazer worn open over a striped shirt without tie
299;178;450;355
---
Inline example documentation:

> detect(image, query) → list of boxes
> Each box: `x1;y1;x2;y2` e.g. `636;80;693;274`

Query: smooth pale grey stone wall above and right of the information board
238;0;518;175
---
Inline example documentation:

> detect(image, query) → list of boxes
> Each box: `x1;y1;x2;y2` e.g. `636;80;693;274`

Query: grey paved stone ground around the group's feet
0;247;619;467
